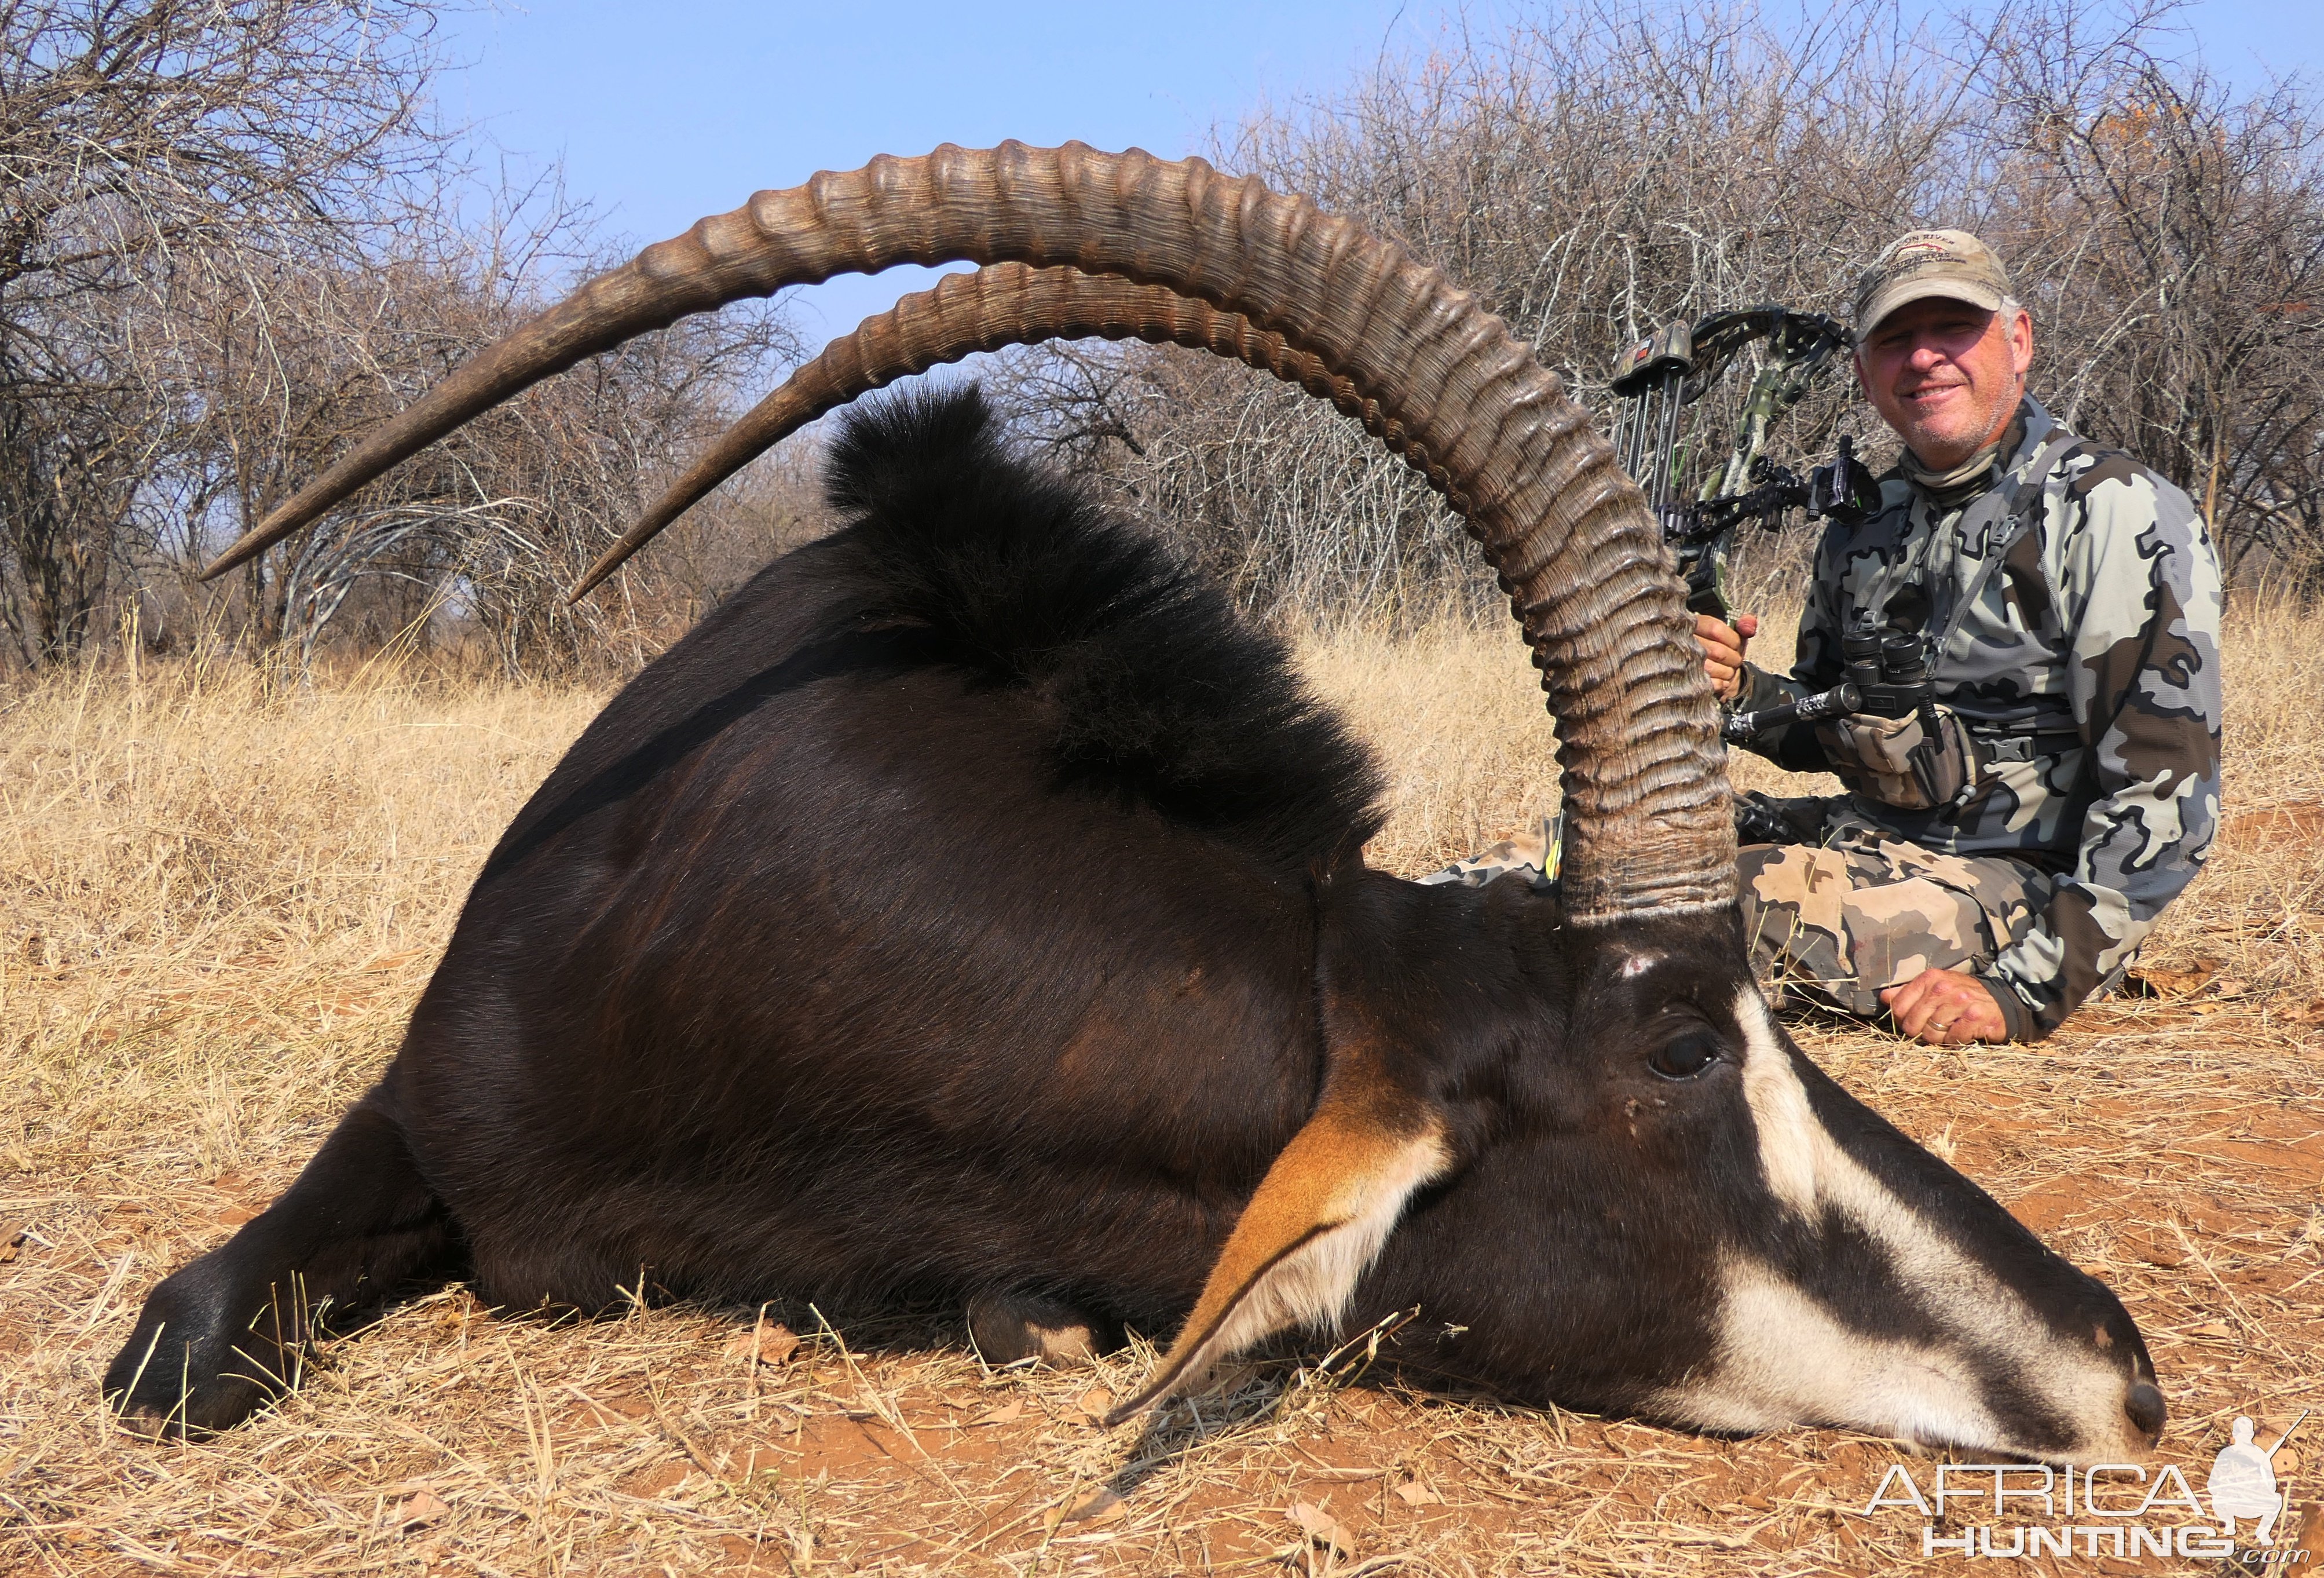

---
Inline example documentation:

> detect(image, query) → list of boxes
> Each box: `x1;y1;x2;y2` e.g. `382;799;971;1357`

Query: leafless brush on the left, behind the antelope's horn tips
0;0;795;671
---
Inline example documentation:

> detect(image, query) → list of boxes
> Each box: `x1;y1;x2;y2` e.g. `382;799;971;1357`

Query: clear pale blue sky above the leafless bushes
441;0;2324;342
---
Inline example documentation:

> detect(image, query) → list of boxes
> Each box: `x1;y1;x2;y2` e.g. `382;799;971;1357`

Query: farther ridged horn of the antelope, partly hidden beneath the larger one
567;262;1394;602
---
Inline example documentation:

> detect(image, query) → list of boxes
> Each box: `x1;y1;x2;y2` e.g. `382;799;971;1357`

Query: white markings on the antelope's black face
1664;988;2147;1462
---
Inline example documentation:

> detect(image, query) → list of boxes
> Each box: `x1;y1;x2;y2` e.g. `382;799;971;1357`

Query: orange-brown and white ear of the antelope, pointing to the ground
1106;1053;1452;1424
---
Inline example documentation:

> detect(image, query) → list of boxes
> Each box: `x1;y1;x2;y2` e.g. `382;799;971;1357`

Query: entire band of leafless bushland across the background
0;0;2324;674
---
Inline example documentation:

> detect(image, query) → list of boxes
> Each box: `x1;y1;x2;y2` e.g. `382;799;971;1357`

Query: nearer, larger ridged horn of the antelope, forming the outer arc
207;142;1736;920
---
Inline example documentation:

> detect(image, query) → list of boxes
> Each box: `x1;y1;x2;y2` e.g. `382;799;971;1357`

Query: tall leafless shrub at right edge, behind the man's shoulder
1987;12;2324;590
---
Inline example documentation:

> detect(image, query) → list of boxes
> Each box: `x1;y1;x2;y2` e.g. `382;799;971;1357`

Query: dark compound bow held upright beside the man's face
1613;307;1880;623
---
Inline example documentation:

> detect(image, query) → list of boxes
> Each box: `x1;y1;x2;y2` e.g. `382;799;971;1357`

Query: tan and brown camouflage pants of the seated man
1420;802;2049;1018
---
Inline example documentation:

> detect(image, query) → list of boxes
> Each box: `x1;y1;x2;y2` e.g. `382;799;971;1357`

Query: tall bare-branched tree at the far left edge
0;0;446;664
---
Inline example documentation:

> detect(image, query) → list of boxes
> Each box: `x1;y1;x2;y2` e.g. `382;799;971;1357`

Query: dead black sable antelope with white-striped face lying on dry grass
105;144;2164;1462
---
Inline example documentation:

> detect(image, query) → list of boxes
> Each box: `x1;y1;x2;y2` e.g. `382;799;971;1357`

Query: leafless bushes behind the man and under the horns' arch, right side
990;0;2324;623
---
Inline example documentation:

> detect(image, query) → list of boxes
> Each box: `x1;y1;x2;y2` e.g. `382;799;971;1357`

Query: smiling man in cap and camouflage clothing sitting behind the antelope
1696;230;2219;1046
